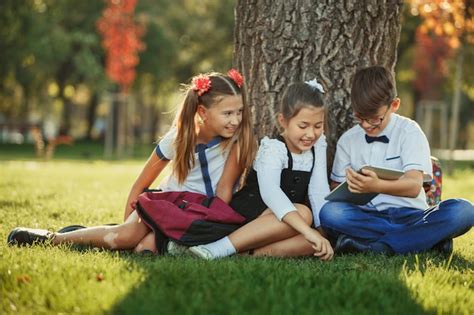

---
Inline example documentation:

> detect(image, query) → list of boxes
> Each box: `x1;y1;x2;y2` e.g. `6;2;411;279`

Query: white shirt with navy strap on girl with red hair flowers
155;128;231;196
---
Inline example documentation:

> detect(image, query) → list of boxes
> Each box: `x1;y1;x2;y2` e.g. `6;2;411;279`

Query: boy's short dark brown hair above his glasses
351;66;397;117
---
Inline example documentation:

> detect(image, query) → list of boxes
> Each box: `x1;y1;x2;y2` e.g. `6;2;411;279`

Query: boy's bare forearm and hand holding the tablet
346;168;423;198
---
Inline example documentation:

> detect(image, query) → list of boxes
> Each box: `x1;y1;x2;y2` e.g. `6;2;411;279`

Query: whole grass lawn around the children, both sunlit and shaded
0;157;474;315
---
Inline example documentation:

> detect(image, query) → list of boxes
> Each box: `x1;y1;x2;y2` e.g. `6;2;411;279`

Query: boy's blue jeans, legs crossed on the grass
319;199;474;254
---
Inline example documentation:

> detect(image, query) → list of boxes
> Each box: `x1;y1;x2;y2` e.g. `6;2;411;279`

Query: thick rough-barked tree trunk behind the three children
234;0;403;168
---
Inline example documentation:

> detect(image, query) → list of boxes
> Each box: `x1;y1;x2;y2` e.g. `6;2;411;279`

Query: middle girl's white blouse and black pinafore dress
230;135;329;226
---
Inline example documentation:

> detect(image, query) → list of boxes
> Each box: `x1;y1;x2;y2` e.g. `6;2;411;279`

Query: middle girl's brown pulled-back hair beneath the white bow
280;83;324;120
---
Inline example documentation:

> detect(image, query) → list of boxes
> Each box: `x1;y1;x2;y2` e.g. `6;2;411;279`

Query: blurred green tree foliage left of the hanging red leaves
0;0;107;137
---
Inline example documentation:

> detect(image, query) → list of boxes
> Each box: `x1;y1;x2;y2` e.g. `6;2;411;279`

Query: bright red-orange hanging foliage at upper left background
97;0;145;93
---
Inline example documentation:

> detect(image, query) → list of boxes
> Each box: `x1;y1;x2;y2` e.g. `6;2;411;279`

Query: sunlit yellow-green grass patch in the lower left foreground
0;247;146;314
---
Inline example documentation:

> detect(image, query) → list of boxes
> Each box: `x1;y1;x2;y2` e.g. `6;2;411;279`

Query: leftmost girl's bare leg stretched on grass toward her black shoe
52;211;150;249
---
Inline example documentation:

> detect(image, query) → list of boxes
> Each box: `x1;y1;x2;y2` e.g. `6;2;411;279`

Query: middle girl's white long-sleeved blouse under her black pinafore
253;135;329;227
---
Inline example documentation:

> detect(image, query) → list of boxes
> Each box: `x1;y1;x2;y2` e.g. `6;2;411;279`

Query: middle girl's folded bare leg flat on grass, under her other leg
253;234;314;257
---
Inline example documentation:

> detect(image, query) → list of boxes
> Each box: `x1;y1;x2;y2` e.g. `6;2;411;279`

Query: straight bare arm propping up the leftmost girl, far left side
124;151;169;220
